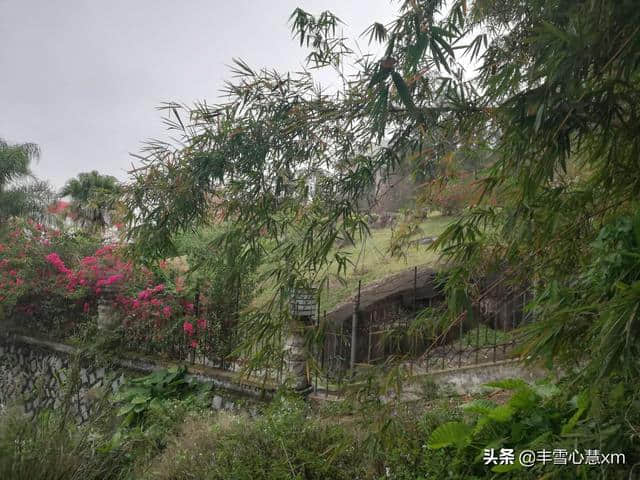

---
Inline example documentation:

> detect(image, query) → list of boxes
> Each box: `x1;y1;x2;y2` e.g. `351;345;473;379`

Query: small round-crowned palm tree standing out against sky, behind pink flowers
60;170;120;231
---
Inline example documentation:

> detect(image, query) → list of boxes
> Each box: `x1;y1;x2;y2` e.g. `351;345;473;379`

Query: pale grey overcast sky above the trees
0;0;398;188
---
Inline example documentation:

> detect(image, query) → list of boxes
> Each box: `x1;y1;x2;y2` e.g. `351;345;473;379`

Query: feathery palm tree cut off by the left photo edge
0;138;54;223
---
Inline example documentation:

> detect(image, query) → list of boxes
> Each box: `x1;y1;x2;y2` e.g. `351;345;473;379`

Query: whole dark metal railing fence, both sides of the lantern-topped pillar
107;268;532;393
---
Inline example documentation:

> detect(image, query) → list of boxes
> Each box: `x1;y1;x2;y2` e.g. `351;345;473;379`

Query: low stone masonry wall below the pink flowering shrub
0;336;269;423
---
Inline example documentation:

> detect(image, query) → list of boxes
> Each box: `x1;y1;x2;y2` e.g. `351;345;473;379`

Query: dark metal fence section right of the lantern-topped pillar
311;272;532;393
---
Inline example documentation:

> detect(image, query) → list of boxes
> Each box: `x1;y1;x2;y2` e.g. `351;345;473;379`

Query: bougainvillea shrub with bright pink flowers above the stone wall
0;222;217;355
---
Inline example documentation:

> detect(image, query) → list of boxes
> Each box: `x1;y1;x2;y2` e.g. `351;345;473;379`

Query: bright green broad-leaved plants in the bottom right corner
428;379;640;479
